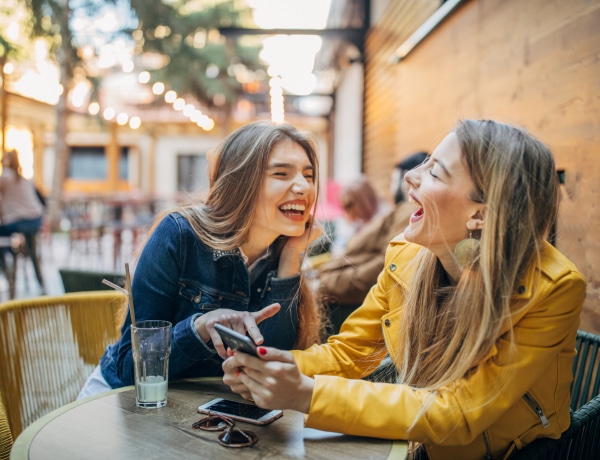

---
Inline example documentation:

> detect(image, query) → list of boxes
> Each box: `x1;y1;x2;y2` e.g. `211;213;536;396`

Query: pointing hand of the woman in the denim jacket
194;303;281;359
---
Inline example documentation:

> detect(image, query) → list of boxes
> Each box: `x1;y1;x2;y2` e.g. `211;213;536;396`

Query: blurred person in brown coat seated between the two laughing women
316;152;427;334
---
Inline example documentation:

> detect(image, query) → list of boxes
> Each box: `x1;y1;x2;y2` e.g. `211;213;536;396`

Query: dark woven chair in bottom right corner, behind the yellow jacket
511;331;600;460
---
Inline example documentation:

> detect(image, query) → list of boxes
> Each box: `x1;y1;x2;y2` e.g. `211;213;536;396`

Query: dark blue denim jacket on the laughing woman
100;213;300;388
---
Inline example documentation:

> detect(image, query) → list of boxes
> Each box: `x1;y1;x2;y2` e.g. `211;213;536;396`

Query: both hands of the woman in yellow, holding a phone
222;347;314;414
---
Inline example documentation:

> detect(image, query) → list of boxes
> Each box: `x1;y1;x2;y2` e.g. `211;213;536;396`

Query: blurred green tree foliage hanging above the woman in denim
131;0;264;106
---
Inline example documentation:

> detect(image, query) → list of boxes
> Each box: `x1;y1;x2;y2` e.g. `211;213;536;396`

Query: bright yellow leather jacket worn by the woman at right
293;237;586;460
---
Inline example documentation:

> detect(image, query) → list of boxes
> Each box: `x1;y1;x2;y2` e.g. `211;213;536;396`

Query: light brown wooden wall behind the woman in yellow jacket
364;0;600;328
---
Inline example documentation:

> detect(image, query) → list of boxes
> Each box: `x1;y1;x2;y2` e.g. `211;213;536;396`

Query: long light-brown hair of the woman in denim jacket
138;121;323;348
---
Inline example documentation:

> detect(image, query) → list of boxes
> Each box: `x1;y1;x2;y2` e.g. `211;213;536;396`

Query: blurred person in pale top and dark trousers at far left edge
0;150;45;293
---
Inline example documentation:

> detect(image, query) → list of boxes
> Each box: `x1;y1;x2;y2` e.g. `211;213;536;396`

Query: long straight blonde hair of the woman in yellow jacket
398;120;560;392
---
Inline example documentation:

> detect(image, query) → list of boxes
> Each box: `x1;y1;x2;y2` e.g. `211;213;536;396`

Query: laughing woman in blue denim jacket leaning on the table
79;122;321;398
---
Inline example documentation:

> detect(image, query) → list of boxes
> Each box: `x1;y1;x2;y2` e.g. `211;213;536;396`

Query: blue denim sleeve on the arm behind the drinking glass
115;215;215;385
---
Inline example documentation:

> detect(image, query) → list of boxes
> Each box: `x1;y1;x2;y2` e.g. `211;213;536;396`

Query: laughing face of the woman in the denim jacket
250;139;316;247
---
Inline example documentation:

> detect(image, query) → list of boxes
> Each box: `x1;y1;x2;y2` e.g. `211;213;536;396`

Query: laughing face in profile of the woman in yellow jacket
404;133;485;264
